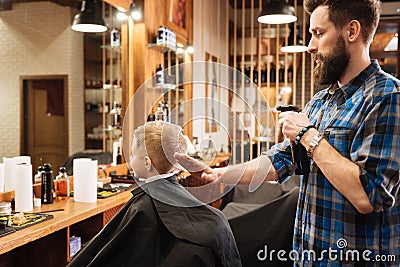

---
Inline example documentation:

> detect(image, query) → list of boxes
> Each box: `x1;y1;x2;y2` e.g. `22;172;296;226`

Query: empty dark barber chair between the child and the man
221;176;299;267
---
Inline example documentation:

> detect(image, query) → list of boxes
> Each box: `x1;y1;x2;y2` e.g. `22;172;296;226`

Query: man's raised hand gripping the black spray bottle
278;111;311;141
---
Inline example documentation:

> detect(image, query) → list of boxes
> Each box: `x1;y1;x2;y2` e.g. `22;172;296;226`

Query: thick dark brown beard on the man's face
313;36;350;85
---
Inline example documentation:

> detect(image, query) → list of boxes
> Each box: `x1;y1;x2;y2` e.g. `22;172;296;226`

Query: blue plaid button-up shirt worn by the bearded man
267;61;400;266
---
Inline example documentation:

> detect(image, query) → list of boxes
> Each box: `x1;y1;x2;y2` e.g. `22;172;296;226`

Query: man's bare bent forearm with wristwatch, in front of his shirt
301;129;373;214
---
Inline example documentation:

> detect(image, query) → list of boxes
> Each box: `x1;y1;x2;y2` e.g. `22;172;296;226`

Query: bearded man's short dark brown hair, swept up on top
303;0;381;43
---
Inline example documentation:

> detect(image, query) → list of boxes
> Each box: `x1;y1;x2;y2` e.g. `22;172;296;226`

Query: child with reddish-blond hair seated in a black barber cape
68;121;241;267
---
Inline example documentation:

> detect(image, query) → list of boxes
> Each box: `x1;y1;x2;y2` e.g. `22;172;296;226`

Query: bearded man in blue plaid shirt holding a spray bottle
175;0;400;266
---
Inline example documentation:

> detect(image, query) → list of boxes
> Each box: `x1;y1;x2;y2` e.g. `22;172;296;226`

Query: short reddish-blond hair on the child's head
134;121;187;174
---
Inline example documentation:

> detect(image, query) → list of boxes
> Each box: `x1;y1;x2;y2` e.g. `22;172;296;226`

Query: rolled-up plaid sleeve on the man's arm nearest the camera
351;92;400;212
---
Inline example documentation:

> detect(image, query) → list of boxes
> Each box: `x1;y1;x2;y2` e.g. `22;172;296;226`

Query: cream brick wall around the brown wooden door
0;1;84;161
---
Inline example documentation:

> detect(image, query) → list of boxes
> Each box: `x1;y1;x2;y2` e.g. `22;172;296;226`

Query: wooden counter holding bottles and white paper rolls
0;190;132;267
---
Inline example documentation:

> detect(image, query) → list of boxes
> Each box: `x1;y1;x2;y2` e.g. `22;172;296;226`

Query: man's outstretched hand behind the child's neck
174;153;223;183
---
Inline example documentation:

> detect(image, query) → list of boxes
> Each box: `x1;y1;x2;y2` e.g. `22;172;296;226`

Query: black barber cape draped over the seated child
68;175;241;267
